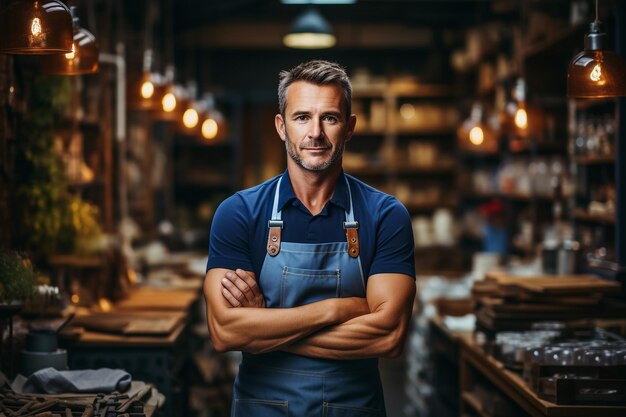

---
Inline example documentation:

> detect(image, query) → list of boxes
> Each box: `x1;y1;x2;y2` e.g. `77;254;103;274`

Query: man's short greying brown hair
278;60;352;120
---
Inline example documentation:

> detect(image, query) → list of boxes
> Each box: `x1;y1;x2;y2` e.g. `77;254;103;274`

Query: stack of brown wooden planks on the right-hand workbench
472;273;626;331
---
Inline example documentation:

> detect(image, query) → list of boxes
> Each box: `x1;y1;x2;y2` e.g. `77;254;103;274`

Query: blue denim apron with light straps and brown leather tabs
231;176;386;417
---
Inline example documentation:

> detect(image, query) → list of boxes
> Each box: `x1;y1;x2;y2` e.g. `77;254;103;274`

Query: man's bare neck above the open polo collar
287;160;341;216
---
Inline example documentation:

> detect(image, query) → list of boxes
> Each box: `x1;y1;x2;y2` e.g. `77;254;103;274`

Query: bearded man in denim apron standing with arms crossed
204;61;415;417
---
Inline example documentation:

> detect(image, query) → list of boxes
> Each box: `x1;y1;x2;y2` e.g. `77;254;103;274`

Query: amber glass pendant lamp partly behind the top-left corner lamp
43;7;98;75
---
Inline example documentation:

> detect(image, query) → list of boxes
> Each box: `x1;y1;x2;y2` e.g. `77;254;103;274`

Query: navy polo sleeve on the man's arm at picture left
207;194;253;271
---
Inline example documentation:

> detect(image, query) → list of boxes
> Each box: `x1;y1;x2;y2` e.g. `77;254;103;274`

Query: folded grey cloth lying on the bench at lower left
22;368;132;394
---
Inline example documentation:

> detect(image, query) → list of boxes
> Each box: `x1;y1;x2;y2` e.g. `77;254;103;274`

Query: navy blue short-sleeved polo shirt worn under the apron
207;171;415;278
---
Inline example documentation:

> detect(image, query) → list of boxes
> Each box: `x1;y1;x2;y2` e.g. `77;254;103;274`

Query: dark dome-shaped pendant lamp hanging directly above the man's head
283;7;337;49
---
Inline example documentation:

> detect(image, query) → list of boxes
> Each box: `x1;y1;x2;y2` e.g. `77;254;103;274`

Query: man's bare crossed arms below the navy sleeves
204;268;415;359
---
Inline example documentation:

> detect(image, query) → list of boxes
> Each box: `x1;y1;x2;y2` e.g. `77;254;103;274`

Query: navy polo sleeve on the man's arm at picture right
370;196;415;277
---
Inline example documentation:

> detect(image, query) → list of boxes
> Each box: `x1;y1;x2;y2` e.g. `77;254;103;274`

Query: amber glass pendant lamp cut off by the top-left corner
0;0;74;54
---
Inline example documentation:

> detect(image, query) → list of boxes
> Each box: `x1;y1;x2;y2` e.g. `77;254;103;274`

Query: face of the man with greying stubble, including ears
276;81;356;171
